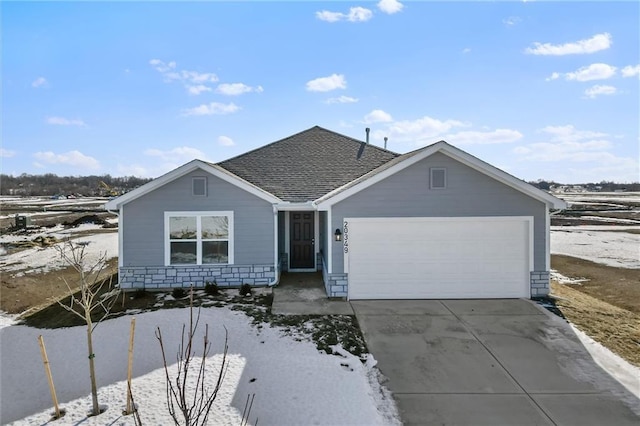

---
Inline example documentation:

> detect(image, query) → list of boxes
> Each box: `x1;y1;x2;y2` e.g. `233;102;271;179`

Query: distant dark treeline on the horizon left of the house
0;173;151;197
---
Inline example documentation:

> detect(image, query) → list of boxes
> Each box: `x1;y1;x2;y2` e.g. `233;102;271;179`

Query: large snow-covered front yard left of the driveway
0;308;400;425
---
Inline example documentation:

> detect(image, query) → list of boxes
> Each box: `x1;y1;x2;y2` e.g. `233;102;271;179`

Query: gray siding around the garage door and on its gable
330;153;548;273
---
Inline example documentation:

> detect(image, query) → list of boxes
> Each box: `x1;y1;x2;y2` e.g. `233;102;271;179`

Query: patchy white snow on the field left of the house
0;223;118;276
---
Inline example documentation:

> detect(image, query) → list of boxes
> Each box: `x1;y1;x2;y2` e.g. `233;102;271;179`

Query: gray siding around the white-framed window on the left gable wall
122;171;274;267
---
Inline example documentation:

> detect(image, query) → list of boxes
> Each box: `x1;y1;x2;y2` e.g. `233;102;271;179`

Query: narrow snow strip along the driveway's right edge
571;324;640;399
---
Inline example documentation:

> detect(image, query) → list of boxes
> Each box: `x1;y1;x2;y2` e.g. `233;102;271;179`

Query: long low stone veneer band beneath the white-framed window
119;265;276;290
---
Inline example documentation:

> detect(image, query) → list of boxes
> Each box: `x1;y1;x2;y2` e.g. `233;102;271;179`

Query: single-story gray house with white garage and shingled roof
105;126;566;299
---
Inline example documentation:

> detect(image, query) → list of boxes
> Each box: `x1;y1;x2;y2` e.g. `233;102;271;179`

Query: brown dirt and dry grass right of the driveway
551;255;640;366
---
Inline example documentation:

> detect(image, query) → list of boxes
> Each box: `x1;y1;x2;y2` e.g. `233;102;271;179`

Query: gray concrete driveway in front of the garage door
351;300;640;426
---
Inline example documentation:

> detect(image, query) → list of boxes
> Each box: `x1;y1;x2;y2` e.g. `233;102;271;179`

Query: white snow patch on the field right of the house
551;226;640;269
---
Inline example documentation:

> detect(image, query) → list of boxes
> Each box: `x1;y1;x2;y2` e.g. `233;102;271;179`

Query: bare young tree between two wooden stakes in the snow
56;241;119;416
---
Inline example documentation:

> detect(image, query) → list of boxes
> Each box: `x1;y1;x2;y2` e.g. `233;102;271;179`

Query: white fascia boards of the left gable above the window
104;160;281;210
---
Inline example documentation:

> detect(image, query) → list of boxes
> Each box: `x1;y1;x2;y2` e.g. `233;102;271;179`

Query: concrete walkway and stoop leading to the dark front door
271;272;354;315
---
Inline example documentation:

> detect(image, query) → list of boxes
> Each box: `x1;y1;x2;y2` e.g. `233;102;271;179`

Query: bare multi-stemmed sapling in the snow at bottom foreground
156;288;228;426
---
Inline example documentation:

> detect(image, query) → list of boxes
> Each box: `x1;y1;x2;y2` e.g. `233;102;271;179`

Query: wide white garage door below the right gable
345;217;533;299
